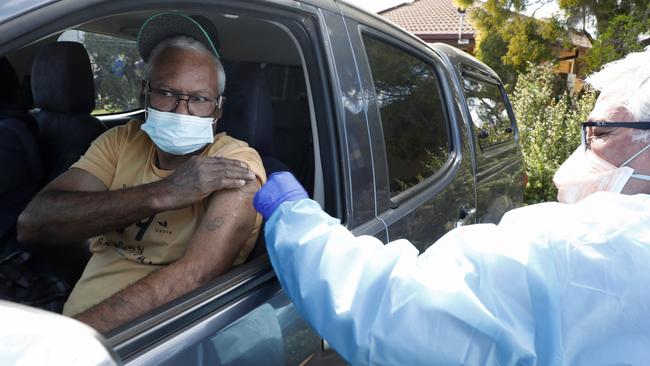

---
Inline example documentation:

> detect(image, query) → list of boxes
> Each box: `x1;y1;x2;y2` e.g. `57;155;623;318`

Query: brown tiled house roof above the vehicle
379;0;476;35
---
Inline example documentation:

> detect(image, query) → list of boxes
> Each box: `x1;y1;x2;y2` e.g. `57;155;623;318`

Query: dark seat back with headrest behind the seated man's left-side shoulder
31;42;106;182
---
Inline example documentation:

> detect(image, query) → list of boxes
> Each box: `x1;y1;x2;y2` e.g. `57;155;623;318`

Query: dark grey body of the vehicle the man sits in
0;0;525;365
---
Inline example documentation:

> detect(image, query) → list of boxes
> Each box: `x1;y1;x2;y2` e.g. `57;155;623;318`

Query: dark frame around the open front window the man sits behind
2;1;344;359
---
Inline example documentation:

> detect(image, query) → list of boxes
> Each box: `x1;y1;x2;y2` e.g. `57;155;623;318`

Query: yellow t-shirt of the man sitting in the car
63;120;266;315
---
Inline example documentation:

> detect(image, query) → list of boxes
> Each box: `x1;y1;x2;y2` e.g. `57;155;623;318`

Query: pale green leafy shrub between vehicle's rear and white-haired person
512;63;596;203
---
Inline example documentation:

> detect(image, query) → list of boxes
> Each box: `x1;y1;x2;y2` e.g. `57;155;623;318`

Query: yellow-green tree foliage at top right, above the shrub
455;0;650;83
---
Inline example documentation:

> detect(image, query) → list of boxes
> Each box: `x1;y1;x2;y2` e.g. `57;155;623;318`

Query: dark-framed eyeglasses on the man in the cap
145;80;223;117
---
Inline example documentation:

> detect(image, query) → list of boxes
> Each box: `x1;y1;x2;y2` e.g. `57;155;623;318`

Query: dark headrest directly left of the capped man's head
32;42;95;114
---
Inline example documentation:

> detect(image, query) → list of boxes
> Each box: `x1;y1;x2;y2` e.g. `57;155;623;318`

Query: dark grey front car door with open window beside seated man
0;0;360;365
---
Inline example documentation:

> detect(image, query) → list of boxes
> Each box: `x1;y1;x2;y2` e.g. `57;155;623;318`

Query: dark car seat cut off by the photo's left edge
0;57;72;312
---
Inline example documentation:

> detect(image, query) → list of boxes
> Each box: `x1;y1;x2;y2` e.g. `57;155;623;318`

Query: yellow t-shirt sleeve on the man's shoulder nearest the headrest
71;126;126;187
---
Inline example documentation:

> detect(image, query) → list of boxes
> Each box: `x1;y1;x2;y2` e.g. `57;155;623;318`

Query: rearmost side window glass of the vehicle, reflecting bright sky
463;78;514;148
